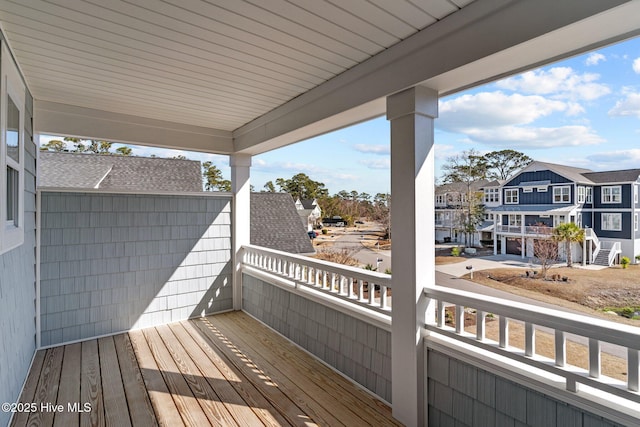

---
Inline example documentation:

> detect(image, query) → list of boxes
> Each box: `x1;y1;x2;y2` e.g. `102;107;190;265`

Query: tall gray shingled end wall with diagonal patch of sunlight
40;192;232;346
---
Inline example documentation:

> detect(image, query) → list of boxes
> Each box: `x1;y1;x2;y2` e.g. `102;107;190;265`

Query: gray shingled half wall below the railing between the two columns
242;274;391;402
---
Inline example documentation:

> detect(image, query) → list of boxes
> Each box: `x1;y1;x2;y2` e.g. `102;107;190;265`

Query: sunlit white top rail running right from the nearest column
424;286;640;350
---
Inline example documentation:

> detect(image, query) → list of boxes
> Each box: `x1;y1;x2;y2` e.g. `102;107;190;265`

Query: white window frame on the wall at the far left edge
0;43;26;253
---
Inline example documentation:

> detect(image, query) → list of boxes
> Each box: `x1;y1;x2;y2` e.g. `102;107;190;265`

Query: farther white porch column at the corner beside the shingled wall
229;154;251;310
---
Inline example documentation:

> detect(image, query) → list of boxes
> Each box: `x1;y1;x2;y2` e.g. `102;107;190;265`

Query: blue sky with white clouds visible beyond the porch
41;38;640;195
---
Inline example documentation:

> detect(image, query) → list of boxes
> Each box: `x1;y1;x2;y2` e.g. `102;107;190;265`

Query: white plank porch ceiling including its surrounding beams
0;0;640;153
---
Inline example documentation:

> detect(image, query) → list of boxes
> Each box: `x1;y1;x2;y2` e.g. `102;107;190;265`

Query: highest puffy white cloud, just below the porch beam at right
496;67;611;101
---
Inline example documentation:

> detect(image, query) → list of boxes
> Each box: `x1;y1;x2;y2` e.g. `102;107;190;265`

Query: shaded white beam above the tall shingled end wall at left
34;101;233;154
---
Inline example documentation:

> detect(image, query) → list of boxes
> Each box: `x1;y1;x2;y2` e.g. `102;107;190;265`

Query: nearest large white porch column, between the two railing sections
387;87;438;426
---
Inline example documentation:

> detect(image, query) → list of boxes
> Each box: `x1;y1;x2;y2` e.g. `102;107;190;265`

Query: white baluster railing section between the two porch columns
242;245;391;315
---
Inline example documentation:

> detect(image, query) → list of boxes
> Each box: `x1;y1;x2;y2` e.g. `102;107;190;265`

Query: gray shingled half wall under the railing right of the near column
428;349;618;427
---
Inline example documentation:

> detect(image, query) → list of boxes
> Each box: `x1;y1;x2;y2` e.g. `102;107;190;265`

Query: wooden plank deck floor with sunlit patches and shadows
12;312;399;426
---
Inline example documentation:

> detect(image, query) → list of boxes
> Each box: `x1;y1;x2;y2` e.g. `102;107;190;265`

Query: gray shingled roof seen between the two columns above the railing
250;193;315;254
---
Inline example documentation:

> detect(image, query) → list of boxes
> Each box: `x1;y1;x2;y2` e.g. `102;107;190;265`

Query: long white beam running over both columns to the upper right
233;0;638;154
